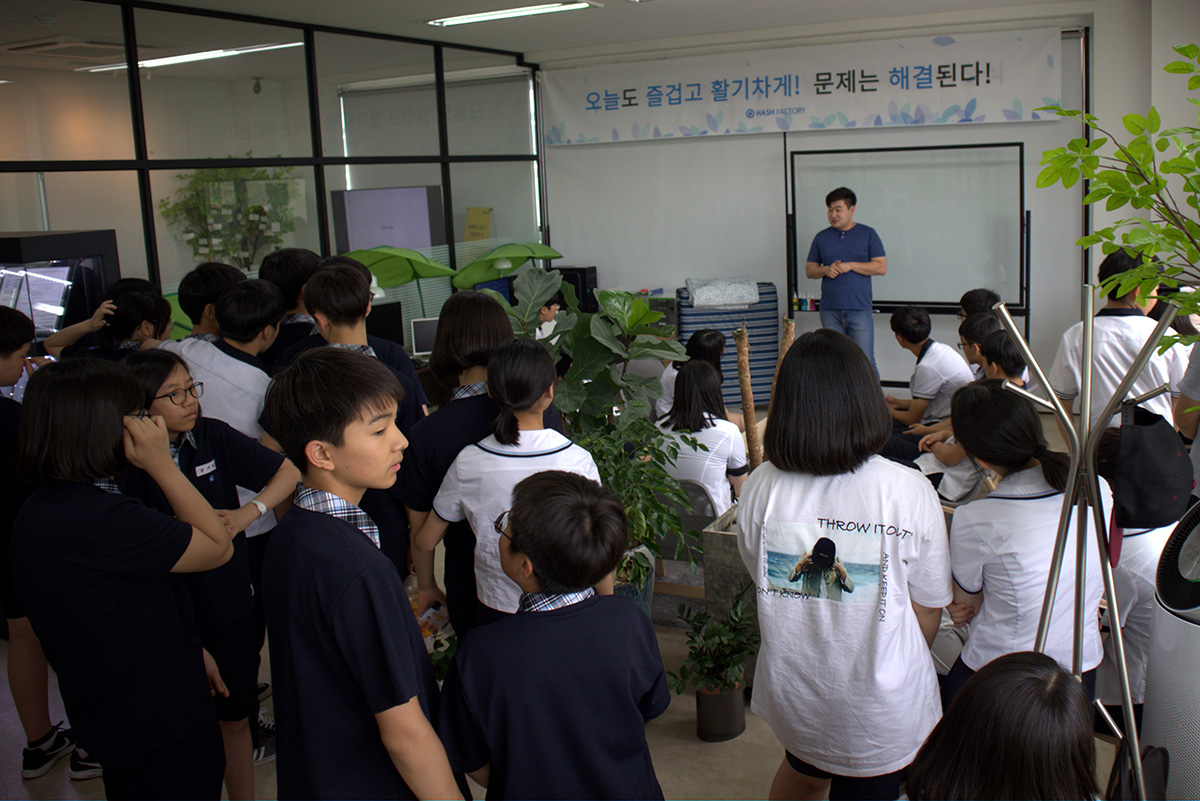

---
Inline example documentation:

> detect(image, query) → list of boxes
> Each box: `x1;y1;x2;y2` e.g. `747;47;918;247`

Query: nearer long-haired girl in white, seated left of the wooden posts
659;361;750;514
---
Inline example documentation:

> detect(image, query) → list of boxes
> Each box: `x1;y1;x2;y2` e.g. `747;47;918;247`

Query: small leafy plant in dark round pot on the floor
667;584;760;742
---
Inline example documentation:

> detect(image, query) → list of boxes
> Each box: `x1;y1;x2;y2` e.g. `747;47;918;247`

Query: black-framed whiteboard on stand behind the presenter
791;144;1025;312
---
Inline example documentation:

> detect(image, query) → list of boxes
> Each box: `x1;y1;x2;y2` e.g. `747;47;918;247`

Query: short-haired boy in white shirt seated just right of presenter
881;306;974;462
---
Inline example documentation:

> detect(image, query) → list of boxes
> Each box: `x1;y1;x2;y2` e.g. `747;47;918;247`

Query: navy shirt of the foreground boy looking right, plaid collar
263;506;437;799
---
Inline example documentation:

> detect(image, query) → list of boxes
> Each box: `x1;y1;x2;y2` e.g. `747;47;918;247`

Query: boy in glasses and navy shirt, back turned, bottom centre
438;470;670;801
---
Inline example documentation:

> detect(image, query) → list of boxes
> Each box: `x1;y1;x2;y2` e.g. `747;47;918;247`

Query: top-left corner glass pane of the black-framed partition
0;0;133;161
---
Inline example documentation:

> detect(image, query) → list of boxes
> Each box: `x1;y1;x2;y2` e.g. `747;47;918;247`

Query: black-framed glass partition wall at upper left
0;0;544;291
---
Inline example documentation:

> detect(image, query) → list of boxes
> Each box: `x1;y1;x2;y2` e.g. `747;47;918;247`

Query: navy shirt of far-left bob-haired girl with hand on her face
12;482;216;767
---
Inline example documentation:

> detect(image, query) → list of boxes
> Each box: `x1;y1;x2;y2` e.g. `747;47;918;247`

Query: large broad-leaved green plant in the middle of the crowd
484;265;695;586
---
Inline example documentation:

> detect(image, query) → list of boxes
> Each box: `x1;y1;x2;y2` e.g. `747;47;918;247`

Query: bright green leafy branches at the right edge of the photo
1037;44;1200;314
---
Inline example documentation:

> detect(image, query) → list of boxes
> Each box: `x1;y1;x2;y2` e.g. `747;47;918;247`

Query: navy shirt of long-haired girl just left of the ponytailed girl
395;395;563;634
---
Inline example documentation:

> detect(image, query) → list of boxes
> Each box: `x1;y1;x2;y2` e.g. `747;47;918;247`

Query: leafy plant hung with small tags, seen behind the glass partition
158;153;296;270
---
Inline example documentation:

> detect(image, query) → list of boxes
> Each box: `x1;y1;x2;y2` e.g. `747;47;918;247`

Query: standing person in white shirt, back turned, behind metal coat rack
1046;249;1188;426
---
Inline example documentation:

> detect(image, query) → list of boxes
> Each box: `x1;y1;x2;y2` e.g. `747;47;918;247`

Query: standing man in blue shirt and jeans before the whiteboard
804;187;888;373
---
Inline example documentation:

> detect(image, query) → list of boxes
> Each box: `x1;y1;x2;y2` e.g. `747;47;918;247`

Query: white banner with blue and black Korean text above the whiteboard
541;28;1062;145
